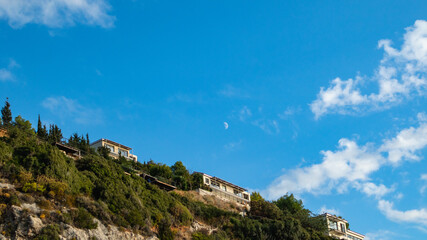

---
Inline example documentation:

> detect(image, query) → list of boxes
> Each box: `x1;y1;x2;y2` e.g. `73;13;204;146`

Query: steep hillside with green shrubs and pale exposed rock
0;106;330;240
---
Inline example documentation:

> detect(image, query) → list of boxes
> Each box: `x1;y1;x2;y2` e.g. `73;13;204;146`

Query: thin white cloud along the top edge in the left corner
0;0;115;28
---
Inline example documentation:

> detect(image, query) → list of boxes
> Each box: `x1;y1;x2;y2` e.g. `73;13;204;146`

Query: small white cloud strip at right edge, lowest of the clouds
378;200;427;226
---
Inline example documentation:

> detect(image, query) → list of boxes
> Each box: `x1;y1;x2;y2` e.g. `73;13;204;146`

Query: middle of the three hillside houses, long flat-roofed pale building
199;172;251;205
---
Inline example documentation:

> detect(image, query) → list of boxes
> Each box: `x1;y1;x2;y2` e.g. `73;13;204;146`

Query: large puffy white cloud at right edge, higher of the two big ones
310;20;427;119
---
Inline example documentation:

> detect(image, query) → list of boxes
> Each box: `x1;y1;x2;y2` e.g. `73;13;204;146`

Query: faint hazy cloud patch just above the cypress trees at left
42;96;103;125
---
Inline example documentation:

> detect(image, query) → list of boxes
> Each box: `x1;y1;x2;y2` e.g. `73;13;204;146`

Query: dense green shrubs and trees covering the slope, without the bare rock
0;113;330;240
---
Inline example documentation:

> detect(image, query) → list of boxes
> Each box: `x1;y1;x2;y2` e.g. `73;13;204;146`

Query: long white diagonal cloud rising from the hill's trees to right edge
266;114;427;199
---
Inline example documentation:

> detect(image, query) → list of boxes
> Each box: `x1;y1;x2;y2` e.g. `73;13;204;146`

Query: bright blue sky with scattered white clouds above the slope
0;0;427;240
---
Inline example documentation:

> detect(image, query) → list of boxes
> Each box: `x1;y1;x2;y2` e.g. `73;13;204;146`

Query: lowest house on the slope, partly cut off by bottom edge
321;213;365;240
